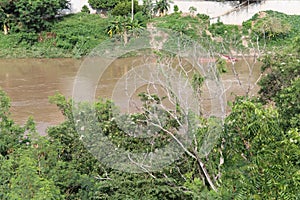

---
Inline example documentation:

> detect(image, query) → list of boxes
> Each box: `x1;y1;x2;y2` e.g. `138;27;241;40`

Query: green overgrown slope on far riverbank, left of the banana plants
0;13;108;58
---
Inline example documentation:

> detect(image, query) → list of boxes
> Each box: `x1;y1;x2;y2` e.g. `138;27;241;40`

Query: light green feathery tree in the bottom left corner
0;90;62;199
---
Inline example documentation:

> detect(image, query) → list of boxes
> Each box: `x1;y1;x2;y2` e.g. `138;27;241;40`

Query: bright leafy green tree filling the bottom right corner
222;99;300;199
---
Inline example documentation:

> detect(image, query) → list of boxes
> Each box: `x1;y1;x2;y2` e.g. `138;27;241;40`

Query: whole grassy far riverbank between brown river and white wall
0;11;300;58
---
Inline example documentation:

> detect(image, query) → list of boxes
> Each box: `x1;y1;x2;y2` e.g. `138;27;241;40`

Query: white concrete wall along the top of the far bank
71;0;300;25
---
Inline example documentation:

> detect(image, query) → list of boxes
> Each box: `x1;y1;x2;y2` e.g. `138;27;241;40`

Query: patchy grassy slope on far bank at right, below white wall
152;11;300;54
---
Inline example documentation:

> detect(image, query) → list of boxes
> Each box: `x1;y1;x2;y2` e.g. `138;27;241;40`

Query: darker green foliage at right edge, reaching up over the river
259;38;300;128
